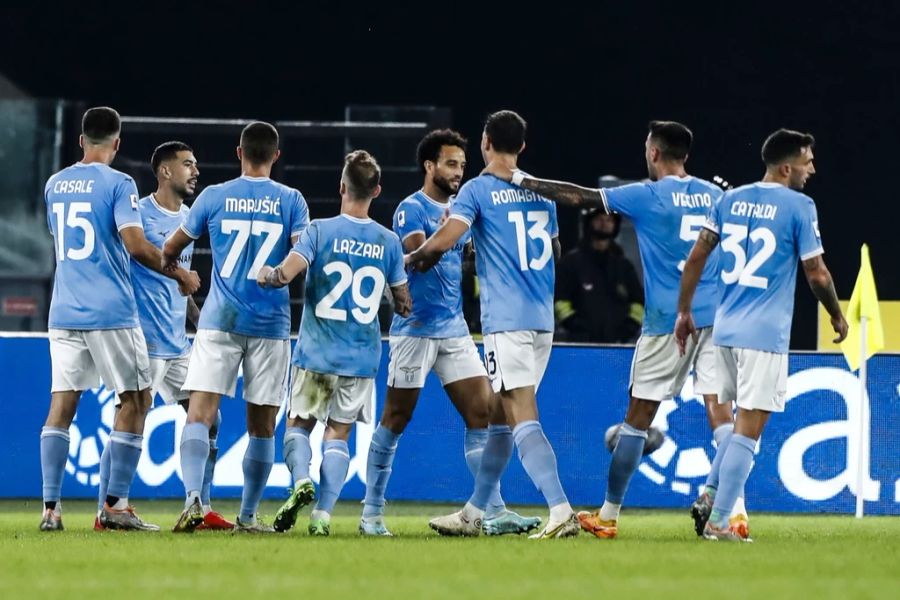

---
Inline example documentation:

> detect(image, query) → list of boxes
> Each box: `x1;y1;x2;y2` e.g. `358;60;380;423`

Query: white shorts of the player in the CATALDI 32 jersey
716;346;788;412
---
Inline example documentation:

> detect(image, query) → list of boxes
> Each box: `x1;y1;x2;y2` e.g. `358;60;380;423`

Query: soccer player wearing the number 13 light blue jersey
408;110;578;539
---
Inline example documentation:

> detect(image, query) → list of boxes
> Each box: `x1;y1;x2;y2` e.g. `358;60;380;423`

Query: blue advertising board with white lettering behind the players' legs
0;337;900;514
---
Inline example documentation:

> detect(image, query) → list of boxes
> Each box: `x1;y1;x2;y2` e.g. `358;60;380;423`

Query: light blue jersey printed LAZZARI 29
291;214;406;377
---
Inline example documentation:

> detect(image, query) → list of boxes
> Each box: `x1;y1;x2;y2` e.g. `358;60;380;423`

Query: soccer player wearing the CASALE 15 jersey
40;106;200;531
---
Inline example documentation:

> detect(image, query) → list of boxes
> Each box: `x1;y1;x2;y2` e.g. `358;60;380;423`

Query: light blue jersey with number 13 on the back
450;175;559;334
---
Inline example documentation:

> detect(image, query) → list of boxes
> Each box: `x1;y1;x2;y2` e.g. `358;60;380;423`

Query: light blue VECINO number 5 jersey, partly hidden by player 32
603;175;722;335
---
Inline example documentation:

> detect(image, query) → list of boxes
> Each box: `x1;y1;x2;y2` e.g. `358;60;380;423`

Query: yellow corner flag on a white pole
841;244;884;371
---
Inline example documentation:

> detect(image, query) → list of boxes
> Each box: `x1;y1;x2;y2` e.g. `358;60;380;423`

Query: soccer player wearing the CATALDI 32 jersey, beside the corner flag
674;129;847;541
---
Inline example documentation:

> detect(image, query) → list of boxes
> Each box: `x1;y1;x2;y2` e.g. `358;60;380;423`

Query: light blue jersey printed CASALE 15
44;163;141;329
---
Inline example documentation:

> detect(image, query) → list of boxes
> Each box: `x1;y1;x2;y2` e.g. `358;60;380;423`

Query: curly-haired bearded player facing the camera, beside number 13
359;129;541;535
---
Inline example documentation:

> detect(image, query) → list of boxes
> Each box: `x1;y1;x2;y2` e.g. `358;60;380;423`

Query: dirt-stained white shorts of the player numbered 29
289;367;375;424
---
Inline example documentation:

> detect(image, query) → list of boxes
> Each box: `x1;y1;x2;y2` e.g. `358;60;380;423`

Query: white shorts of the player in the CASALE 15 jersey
49;327;150;394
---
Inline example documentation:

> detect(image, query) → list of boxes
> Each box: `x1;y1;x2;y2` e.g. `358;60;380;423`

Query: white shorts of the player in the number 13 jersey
484;331;553;393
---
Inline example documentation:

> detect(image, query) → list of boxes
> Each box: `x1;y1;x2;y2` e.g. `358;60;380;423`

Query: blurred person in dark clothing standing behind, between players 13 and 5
554;209;644;343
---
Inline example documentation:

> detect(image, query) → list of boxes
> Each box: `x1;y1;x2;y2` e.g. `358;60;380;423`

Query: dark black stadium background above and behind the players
0;0;900;348
